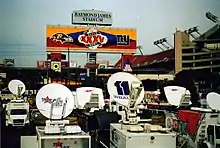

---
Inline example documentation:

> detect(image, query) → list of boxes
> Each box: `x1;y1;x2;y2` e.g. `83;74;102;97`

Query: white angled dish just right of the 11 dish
164;86;186;106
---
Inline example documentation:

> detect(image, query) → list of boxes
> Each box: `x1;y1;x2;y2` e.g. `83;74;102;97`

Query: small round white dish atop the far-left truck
8;80;26;95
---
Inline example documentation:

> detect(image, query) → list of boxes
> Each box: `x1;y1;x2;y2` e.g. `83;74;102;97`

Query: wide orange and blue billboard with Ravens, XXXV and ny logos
46;25;137;54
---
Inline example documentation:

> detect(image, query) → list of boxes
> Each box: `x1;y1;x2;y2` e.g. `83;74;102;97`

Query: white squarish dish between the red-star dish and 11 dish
76;87;105;109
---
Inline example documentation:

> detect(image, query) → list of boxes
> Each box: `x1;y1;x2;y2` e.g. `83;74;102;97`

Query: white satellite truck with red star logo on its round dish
21;83;91;148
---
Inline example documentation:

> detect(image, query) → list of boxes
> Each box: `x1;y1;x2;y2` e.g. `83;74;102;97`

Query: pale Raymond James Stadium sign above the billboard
72;10;112;26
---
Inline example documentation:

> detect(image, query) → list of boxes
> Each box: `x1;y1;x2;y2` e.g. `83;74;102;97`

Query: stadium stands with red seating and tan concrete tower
115;24;220;93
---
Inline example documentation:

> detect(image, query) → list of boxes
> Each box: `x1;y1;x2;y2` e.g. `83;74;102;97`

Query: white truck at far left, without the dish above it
5;100;29;126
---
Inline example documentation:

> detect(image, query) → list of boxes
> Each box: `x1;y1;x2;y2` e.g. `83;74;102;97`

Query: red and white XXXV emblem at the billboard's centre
78;28;108;50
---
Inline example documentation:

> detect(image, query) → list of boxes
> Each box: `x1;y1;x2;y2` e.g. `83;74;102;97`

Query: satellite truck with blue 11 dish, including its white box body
107;72;176;148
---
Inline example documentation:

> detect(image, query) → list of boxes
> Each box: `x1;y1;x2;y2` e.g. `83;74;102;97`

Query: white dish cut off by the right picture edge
206;92;220;111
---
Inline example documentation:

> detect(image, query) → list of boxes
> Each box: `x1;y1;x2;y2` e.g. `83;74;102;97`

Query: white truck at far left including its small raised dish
5;80;29;126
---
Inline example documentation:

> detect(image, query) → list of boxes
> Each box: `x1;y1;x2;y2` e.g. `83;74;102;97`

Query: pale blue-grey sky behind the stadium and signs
0;0;220;66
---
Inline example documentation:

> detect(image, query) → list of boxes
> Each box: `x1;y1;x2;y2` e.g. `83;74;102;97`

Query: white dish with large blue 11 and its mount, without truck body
107;72;144;124
